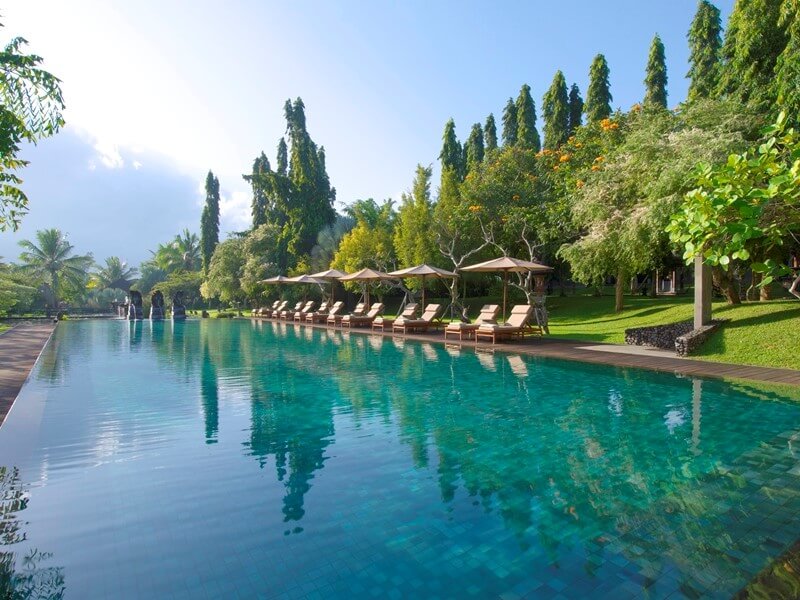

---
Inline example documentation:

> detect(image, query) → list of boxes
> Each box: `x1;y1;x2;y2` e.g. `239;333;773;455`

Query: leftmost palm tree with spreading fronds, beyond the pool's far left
19;229;94;308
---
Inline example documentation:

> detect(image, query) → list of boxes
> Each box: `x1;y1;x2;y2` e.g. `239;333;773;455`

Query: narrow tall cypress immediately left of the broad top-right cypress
686;0;722;101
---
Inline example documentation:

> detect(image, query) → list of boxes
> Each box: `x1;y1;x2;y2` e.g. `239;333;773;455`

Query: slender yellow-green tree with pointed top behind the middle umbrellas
394;165;439;285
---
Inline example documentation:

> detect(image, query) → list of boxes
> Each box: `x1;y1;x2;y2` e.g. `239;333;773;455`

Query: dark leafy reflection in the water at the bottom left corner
0;467;65;600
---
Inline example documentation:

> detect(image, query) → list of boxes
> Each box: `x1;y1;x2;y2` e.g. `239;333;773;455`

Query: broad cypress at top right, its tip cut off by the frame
719;0;787;104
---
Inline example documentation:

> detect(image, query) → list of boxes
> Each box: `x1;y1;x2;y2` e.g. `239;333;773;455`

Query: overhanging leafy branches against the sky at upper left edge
0;25;64;231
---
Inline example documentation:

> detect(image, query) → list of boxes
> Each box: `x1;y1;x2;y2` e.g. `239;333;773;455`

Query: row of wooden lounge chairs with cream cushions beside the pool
247;300;534;344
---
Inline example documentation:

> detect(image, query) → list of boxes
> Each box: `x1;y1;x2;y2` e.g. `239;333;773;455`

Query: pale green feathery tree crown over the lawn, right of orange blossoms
561;101;756;292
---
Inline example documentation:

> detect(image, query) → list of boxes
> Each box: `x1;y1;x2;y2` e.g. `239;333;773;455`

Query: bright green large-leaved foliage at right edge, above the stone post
667;113;800;285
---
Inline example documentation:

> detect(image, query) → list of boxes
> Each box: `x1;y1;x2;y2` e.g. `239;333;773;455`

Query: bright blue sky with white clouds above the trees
0;0;734;265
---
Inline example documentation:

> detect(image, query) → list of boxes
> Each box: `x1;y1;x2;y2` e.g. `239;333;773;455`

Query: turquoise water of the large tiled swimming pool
0;320;800;598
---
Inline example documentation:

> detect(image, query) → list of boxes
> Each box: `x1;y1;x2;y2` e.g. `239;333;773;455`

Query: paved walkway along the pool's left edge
0;321;56;425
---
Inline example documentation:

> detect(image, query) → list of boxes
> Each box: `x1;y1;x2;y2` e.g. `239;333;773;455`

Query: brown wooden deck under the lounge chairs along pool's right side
246;317;800;386
